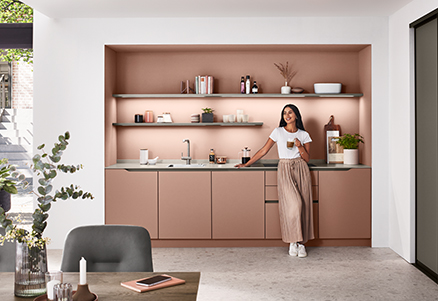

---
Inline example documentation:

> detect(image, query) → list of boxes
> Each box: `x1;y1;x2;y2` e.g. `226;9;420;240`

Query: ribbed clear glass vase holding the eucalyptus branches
14;242;47;297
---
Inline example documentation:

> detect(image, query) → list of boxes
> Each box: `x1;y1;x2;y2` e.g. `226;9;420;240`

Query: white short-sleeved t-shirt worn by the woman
269;127;312;159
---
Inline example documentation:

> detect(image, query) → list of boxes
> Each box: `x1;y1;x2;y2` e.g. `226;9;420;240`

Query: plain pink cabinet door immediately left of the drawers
212;171;265;239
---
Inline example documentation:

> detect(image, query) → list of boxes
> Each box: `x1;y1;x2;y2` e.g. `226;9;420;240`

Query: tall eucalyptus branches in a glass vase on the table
0;132;94;297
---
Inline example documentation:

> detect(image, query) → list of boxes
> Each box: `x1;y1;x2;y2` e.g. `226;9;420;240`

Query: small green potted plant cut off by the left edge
0;158;27;212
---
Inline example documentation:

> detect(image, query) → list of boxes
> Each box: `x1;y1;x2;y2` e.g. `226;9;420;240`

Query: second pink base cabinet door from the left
158;171;211;239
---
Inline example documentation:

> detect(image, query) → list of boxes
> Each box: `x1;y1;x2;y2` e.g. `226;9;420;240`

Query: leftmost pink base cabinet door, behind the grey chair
105;169;158;239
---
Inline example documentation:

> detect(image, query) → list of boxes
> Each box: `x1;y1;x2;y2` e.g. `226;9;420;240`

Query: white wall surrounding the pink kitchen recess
34;12;389;248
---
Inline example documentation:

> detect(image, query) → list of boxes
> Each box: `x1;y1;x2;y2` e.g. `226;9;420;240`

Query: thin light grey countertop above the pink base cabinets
106;159;371;171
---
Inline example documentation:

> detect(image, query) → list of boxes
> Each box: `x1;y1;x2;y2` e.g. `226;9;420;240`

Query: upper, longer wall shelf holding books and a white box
113;93;363;98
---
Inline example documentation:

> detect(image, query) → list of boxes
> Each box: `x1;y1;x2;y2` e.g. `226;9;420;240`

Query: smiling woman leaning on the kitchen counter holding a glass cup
236;104;314;257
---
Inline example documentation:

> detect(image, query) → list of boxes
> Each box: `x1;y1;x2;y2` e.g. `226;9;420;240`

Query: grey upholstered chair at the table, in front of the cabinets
61;225;153;272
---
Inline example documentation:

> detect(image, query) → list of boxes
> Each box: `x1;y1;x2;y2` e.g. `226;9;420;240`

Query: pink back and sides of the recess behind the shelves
105;45;371;166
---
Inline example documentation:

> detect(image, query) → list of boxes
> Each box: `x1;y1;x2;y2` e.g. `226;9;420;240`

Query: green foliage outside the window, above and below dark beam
0;0;33;64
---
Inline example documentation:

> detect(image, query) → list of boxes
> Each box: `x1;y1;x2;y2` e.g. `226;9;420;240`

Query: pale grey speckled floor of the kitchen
49;247;438;301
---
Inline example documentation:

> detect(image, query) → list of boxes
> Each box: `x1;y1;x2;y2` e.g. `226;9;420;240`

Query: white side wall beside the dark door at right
388;0;438;262
